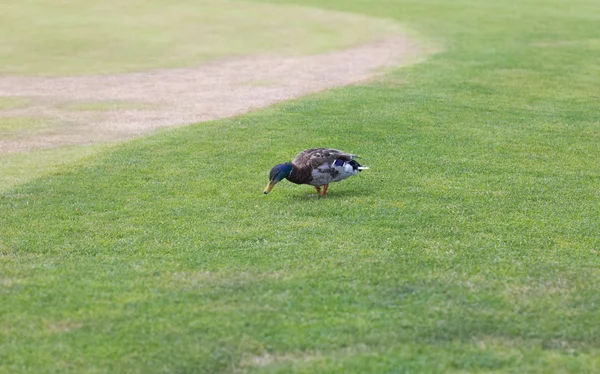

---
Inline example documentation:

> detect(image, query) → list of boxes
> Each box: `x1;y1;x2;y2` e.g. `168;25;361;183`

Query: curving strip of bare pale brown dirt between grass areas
0;37;416;154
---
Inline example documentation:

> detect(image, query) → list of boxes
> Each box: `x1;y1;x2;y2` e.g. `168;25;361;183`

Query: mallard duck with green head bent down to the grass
264;148;368;196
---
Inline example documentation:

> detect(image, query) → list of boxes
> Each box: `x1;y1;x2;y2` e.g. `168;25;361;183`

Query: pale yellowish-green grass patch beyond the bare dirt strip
0;0;399;75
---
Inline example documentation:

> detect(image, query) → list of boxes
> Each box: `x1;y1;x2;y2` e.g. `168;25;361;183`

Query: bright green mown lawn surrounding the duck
0;0;600;373
